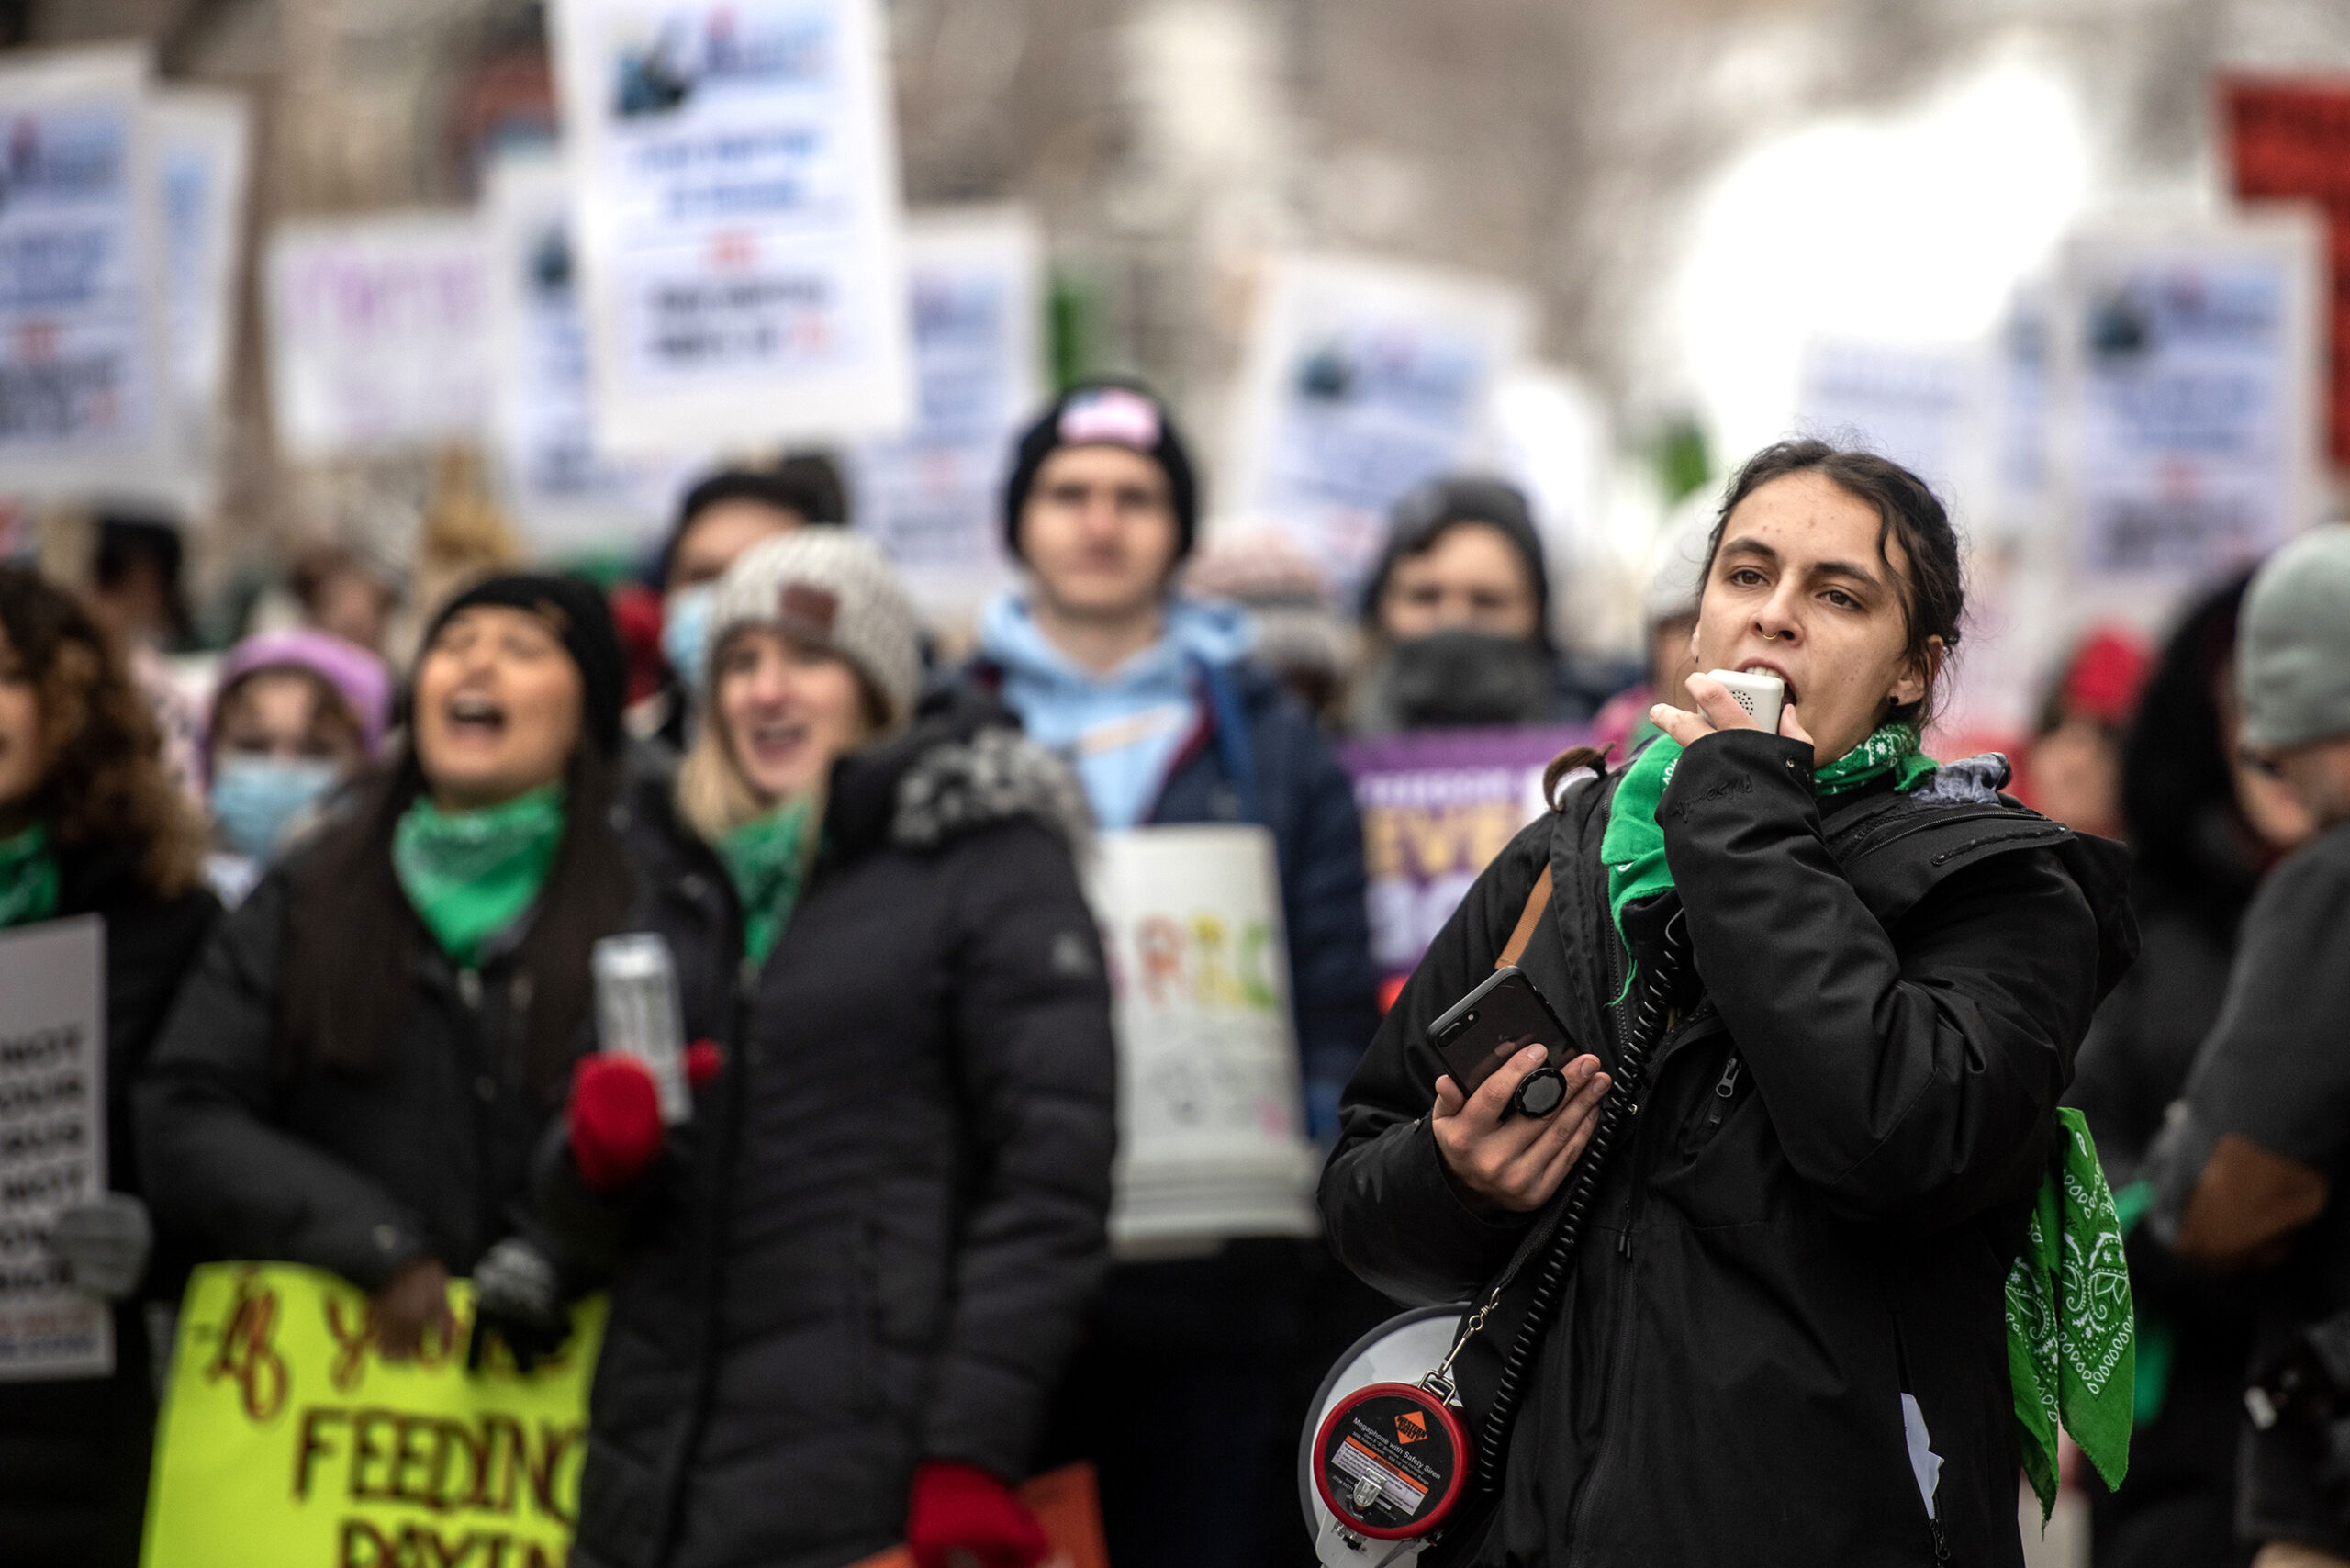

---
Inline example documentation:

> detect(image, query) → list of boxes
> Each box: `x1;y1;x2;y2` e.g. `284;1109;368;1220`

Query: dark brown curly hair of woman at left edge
0;565;205;898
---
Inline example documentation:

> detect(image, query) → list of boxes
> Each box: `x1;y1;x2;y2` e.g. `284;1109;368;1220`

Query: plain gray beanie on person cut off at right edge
2235;524;2350;747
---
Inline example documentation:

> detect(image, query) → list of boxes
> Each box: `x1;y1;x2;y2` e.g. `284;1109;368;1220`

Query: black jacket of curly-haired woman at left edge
0;851;221;1568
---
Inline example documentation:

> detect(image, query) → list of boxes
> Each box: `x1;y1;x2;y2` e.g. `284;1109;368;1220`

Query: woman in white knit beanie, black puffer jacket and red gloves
541;529;1113;1568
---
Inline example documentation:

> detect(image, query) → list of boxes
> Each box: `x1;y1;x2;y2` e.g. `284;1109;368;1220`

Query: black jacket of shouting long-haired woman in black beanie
136;839;606;1293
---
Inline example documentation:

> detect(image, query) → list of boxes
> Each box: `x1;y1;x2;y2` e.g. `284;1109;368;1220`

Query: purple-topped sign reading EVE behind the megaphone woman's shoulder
1339;724;1589;988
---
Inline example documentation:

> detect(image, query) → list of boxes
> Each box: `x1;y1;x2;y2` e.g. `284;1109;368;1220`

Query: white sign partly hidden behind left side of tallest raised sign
487;151;691;550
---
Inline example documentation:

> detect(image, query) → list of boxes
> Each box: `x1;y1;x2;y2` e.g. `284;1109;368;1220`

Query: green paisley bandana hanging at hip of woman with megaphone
2007;1105;2139;1526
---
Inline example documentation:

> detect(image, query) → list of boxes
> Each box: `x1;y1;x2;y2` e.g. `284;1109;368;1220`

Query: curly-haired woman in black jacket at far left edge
0;566;221;1568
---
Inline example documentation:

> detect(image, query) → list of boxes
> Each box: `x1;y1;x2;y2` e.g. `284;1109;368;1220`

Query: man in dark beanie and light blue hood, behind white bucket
970;383;1386;1568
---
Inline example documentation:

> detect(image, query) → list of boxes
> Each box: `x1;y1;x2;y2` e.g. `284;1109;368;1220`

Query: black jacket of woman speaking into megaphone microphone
1323;731;2133;1568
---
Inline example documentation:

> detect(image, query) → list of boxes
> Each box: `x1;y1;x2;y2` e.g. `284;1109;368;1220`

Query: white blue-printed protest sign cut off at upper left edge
0;50;176;494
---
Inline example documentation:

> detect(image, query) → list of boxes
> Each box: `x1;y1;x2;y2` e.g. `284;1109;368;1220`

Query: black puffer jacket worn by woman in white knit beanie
565;696;1113;1568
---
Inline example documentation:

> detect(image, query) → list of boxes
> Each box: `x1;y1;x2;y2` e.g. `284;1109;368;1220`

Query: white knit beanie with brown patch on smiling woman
710;527;922;724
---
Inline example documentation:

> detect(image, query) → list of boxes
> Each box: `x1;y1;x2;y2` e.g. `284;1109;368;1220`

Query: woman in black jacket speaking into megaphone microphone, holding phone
1321;442;2136;1568
